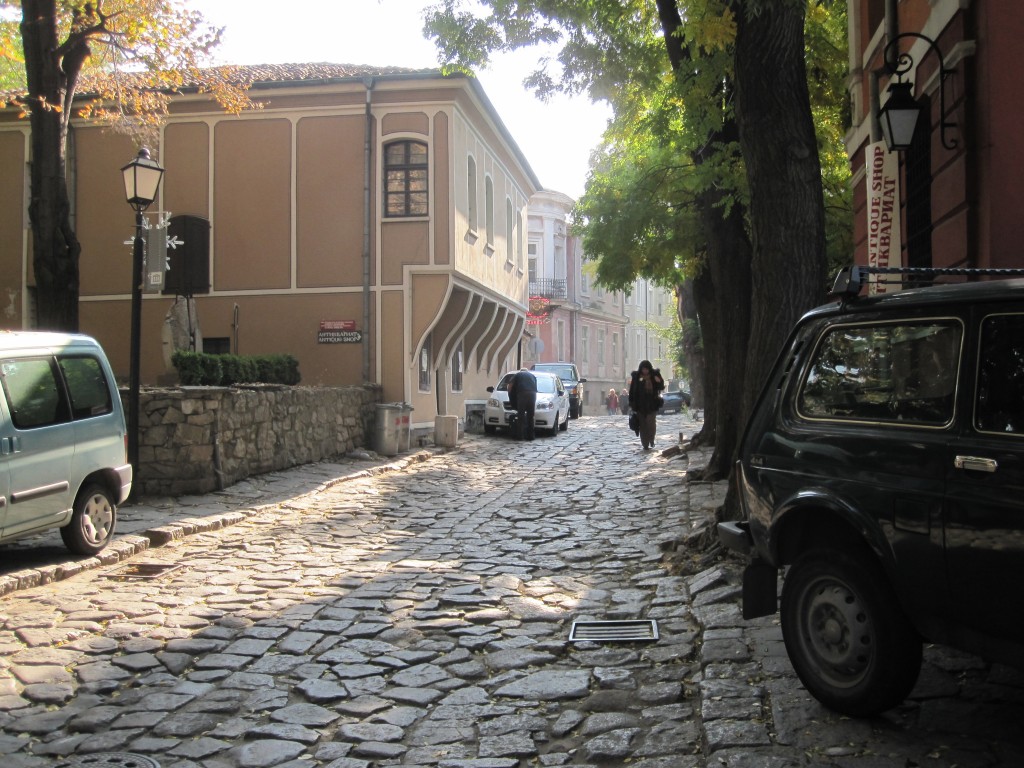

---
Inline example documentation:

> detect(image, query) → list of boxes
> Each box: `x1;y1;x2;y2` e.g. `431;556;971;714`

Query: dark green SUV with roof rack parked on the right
719;267;1024;716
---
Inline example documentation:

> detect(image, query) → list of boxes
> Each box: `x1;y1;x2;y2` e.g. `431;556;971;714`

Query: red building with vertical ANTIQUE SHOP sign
847;0;1024;286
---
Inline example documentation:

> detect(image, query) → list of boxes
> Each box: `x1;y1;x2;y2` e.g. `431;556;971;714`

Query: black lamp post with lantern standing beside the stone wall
121;147;164;473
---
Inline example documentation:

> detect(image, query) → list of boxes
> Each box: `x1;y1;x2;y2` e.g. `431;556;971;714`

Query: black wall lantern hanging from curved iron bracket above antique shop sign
879;32;956;152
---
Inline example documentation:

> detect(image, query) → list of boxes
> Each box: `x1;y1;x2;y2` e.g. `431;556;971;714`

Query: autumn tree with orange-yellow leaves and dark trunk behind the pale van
0;0;251;331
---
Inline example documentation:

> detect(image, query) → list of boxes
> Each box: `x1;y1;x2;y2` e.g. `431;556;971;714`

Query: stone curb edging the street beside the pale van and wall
0;449;442;597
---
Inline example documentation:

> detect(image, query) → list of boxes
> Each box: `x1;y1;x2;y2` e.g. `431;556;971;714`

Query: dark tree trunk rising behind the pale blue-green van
22;0;81;331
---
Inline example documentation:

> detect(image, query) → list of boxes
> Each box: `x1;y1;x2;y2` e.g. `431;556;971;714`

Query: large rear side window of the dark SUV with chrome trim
797;318;964;426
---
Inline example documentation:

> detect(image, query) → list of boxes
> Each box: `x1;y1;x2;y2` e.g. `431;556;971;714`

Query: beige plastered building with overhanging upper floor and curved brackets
0;65;540;434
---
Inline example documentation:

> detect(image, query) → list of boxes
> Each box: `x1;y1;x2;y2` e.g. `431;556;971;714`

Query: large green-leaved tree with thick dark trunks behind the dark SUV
425;0;850;475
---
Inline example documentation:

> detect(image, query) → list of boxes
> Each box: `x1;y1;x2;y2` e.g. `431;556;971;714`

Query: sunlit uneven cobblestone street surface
0;416;1024;768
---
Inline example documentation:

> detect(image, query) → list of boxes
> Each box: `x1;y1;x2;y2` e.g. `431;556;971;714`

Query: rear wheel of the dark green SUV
781;549;922;717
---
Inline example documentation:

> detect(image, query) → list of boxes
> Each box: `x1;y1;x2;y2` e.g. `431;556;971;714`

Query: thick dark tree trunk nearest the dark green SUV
735;2;825;434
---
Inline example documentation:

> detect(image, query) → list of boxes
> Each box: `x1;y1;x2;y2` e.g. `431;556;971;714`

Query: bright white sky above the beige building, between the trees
193;0;611;199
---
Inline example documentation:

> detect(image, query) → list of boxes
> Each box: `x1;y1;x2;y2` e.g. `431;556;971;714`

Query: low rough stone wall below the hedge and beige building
121;385;381;496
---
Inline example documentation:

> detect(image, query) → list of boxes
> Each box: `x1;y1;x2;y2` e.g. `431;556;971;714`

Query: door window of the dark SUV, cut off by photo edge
974;314;1024;434
